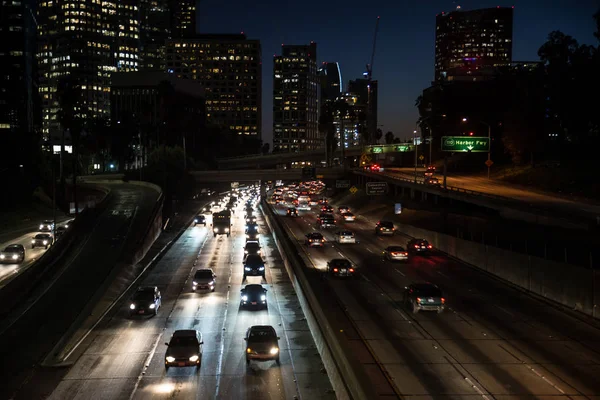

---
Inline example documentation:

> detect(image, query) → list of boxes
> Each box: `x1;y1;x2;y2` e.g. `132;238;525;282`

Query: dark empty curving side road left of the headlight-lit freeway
0;184;158;399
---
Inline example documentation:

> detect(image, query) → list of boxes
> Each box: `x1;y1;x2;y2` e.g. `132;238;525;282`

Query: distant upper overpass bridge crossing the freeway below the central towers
217;143;414;170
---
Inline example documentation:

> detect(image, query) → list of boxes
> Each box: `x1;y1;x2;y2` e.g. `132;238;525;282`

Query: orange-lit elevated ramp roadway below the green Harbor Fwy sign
383;168;600;217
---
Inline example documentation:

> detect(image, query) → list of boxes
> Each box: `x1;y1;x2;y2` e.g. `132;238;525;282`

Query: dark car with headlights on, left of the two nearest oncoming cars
165;329;204;370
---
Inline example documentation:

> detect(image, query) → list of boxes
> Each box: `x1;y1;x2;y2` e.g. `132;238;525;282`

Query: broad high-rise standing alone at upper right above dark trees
435;7;514;81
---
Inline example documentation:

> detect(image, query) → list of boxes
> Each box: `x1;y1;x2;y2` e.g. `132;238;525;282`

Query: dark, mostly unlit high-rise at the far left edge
0;0;38;139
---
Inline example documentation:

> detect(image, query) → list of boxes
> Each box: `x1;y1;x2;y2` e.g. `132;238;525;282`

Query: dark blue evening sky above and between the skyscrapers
198;0;600;142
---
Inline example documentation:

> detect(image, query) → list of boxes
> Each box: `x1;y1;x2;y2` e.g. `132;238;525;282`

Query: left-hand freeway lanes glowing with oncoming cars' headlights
45;196;335;400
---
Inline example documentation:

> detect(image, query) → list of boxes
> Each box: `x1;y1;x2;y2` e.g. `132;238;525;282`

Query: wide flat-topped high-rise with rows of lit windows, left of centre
166;34;262;139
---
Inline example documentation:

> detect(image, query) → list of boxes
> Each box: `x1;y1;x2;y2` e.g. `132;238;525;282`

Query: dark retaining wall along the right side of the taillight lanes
398;224;600;318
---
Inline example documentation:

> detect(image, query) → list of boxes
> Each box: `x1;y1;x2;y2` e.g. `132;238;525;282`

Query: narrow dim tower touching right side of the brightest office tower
139;0;171;71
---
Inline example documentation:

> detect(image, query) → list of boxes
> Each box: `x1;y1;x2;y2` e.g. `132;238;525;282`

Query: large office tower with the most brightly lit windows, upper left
37;0;140;143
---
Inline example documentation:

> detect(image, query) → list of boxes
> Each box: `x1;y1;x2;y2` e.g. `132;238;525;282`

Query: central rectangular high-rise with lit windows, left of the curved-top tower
273;42;323;152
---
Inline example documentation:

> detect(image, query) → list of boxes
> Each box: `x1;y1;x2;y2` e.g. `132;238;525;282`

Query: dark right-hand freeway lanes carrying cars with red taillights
274;202;600;399
